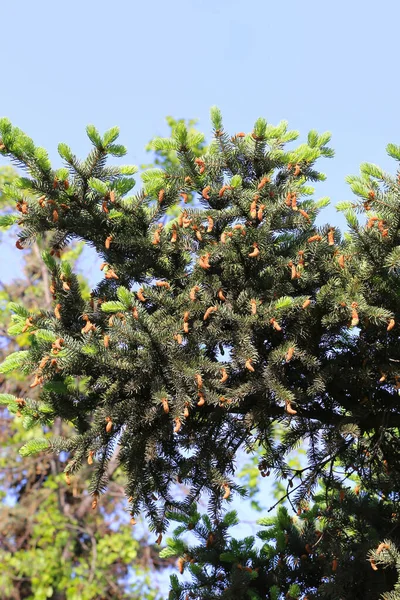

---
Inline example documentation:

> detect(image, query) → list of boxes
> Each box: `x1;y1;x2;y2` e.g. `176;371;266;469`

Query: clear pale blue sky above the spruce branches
0;0;400;576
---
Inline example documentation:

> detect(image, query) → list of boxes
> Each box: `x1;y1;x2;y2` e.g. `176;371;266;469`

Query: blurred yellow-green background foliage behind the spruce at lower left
0;169;168;600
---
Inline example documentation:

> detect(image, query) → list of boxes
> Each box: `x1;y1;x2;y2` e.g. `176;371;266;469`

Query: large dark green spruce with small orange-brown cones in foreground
0;108;400;598
